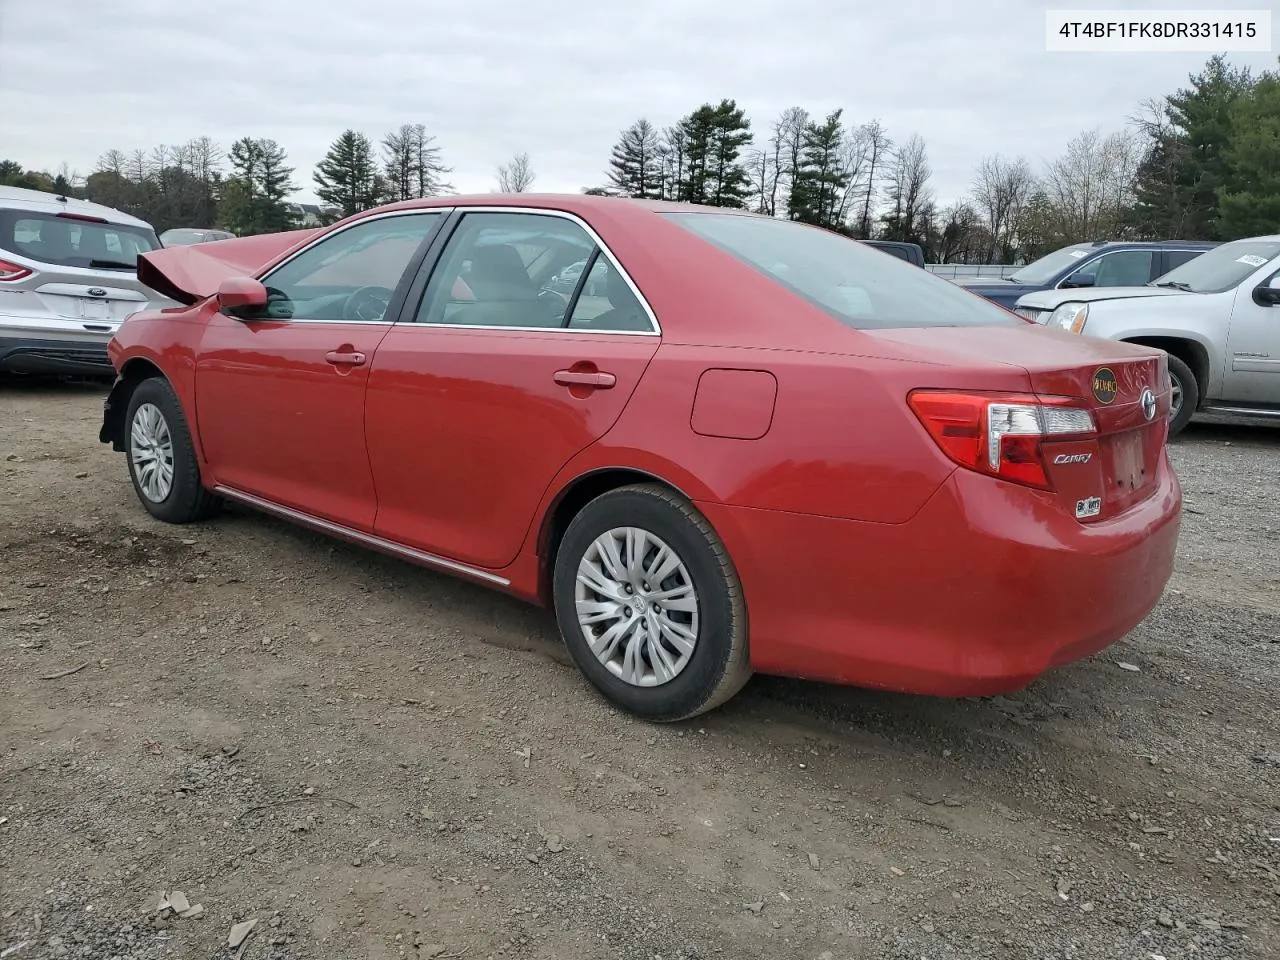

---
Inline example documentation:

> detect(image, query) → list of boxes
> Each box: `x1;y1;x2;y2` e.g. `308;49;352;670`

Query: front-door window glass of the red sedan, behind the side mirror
254;211;442;323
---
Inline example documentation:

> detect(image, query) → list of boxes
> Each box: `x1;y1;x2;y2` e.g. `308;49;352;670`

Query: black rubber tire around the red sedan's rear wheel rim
553;484;751;723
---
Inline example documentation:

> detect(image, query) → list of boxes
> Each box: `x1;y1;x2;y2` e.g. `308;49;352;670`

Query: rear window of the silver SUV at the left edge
0;210;160;270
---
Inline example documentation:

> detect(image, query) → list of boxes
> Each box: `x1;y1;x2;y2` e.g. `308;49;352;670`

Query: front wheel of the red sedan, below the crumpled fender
124;376;218;524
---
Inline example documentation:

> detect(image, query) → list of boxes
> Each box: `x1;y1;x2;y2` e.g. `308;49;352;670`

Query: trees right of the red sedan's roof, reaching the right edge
599;56;1280;262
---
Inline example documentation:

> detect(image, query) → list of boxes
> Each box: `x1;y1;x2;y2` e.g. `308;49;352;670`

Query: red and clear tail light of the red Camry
908;390;1097;490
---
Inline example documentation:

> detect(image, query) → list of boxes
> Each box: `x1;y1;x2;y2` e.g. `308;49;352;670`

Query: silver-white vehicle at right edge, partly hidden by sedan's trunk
1015;236;1280;435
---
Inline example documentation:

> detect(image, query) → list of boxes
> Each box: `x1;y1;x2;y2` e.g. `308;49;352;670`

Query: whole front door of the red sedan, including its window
196;210;443;532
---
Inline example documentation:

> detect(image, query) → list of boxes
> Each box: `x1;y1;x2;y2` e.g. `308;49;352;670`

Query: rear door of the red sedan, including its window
365;211;659;568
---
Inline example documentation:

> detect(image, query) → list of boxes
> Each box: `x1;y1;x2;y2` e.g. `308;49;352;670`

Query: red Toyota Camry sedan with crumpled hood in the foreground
101;195;1181;721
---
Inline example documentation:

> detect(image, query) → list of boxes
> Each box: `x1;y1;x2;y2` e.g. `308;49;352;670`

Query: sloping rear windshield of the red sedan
663;212;1024;330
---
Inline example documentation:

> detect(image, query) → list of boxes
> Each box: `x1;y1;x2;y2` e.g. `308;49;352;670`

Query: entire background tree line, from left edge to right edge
0;56;1280;262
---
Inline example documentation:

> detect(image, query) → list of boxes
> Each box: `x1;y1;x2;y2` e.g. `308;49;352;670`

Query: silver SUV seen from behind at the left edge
0;187;177;376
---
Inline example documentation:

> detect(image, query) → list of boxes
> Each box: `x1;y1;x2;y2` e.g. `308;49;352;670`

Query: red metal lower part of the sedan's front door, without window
196;312;390;531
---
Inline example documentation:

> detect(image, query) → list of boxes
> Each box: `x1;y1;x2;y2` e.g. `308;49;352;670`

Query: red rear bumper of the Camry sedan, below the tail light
699;457;1181;696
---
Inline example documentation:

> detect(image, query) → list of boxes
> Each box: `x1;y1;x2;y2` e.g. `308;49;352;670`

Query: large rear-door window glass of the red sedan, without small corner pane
417;212;595;329
